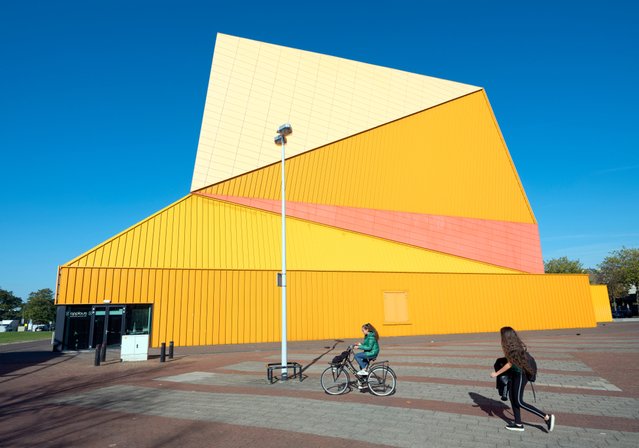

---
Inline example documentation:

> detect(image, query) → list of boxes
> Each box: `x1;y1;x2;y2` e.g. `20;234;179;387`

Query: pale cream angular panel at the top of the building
191;34;480;191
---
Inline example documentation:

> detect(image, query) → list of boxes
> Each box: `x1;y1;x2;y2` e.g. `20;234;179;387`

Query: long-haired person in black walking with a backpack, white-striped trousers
490;327;555;432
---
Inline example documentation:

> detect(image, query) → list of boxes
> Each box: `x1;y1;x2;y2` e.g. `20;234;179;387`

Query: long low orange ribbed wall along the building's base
57;267;595;347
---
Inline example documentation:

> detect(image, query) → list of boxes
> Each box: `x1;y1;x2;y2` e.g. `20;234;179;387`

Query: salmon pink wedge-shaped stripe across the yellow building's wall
195;193;544;274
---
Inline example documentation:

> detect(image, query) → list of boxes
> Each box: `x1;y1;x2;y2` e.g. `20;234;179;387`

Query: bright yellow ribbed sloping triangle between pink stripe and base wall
67;196;514;274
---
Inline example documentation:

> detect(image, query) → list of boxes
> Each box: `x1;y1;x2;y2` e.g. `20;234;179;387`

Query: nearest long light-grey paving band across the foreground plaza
55;386;639;447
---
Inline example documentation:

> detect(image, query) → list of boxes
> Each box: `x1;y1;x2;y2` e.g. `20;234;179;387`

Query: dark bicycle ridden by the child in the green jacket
320;345;397;397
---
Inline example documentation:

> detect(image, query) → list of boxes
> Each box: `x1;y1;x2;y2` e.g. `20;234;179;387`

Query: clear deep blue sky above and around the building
0;0;639;300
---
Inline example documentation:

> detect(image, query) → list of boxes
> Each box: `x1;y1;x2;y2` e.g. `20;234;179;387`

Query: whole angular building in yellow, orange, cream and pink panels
56;34;609;349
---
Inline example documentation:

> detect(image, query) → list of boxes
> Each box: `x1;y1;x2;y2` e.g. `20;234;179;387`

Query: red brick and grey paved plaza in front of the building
0;321;639;448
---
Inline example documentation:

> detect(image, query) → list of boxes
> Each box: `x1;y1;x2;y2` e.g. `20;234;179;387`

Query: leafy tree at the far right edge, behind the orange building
598;247;639;298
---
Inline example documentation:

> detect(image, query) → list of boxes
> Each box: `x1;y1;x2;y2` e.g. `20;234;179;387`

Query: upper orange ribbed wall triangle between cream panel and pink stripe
203;91;535;223
